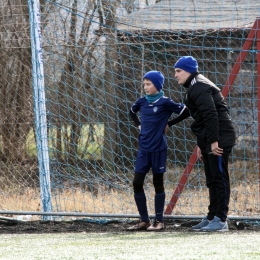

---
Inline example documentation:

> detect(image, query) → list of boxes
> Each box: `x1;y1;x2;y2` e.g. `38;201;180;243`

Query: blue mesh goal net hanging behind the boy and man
0;0;260;216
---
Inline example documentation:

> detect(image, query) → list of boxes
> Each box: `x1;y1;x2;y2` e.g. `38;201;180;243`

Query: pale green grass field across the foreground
0;232;260;260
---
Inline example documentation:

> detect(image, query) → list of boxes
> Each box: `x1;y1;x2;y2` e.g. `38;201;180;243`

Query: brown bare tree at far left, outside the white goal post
0;0;33;163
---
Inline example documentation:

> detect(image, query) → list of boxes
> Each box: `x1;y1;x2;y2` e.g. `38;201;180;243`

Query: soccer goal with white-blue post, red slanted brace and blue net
0;0;260;218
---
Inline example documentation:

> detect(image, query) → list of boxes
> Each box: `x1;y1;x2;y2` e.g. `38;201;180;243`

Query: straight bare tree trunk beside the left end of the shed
100;0;119;172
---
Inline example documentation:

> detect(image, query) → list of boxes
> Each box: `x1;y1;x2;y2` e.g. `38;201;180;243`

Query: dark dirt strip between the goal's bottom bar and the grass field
0;219;260;234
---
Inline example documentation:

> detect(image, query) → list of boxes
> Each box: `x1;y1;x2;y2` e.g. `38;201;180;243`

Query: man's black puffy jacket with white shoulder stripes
183;72;236;153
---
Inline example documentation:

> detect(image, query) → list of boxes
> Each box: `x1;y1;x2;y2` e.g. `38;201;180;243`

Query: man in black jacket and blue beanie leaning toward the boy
168;56;236;231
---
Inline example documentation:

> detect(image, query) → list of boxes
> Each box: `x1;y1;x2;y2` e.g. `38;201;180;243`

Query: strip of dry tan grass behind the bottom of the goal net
0;183;260;216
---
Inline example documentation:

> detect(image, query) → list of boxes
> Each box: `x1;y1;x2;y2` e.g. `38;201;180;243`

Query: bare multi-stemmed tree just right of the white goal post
40;0;106;164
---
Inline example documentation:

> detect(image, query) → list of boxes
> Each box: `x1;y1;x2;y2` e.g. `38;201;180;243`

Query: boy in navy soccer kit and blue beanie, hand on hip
128;71;186;231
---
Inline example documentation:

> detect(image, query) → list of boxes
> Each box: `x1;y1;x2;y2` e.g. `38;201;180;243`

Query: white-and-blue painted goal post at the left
28;0;52;219
